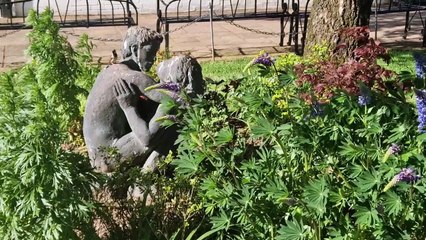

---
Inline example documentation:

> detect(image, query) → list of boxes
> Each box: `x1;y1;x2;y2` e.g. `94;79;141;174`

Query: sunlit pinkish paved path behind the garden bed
0;13;422;71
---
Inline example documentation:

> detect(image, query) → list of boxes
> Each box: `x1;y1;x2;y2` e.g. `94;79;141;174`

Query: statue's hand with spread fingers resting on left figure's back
113;79;139;109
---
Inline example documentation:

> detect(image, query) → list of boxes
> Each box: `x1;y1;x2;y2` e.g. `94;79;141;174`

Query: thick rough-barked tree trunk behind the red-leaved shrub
305;0;373;55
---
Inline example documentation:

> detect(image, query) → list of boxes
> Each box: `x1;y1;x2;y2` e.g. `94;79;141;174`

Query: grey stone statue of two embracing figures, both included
83;27;204;172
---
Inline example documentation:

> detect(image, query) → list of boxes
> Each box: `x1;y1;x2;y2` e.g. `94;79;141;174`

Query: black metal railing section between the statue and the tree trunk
157;0;310;53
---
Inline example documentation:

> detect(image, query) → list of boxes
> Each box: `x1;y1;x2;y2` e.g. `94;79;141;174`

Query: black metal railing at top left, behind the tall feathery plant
0;0;138;30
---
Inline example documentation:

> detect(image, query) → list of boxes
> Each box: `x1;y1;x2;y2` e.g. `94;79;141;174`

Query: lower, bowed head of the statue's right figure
157;55;205;96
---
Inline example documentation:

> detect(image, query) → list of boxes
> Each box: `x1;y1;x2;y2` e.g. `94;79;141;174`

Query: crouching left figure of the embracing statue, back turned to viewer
83;27;164;172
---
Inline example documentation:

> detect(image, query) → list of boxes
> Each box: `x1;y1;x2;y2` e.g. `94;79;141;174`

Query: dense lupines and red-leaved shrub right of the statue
167;28;426;240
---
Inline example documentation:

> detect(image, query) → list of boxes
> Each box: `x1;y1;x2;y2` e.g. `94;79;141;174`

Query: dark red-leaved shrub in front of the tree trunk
296;27;392;104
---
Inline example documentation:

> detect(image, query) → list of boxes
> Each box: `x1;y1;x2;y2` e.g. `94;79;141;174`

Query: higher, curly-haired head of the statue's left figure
121;26;163;72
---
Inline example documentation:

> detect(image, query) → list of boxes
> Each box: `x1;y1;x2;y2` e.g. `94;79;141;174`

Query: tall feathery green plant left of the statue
0;8;99;239
